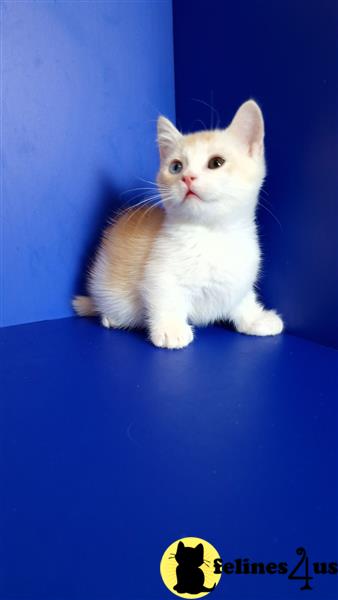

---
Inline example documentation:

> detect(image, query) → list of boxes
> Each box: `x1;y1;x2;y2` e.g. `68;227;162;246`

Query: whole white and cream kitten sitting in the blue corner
73;100;283;348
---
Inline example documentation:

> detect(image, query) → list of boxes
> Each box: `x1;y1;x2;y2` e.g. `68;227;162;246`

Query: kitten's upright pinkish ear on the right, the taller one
230;100;264;156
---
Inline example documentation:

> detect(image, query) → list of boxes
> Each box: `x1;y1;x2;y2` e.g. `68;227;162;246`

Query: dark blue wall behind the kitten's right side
173;0;338;345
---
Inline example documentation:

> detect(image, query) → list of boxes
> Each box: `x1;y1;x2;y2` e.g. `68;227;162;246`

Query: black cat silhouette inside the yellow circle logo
174;542;216;594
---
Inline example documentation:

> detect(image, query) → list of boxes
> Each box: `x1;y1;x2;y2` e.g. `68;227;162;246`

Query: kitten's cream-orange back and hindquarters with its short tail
73;206;164;327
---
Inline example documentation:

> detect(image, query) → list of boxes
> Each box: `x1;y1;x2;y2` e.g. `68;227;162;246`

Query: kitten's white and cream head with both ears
157;100;265;224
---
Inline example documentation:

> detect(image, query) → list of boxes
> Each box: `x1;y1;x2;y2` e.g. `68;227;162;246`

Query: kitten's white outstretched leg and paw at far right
229;290;284;336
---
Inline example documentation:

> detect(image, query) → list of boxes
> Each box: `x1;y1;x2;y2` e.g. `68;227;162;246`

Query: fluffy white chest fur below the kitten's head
149;219;260;324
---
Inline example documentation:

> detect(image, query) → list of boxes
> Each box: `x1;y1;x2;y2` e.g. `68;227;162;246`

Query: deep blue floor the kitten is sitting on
0;318;338;600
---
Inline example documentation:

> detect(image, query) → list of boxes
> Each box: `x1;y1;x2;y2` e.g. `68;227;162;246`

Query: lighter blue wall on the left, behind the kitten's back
1;0;175;325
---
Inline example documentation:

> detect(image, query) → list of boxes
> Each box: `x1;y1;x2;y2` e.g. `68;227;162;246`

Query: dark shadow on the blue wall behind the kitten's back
74;175;126;294
